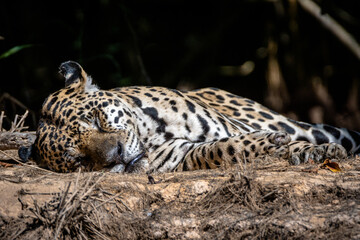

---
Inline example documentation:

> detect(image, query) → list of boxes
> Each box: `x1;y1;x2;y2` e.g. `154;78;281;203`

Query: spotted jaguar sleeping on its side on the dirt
19;61;360;173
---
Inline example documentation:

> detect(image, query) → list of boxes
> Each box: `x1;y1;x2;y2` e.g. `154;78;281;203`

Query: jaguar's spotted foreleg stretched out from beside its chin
176;131;290;171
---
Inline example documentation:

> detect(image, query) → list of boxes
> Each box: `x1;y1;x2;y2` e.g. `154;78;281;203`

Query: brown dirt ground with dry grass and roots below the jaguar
0;157;360;239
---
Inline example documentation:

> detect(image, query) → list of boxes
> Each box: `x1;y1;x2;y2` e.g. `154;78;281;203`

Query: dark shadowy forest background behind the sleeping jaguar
0;0;360;130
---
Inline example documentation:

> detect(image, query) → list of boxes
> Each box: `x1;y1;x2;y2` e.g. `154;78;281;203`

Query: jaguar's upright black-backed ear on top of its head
59;61;87;87
